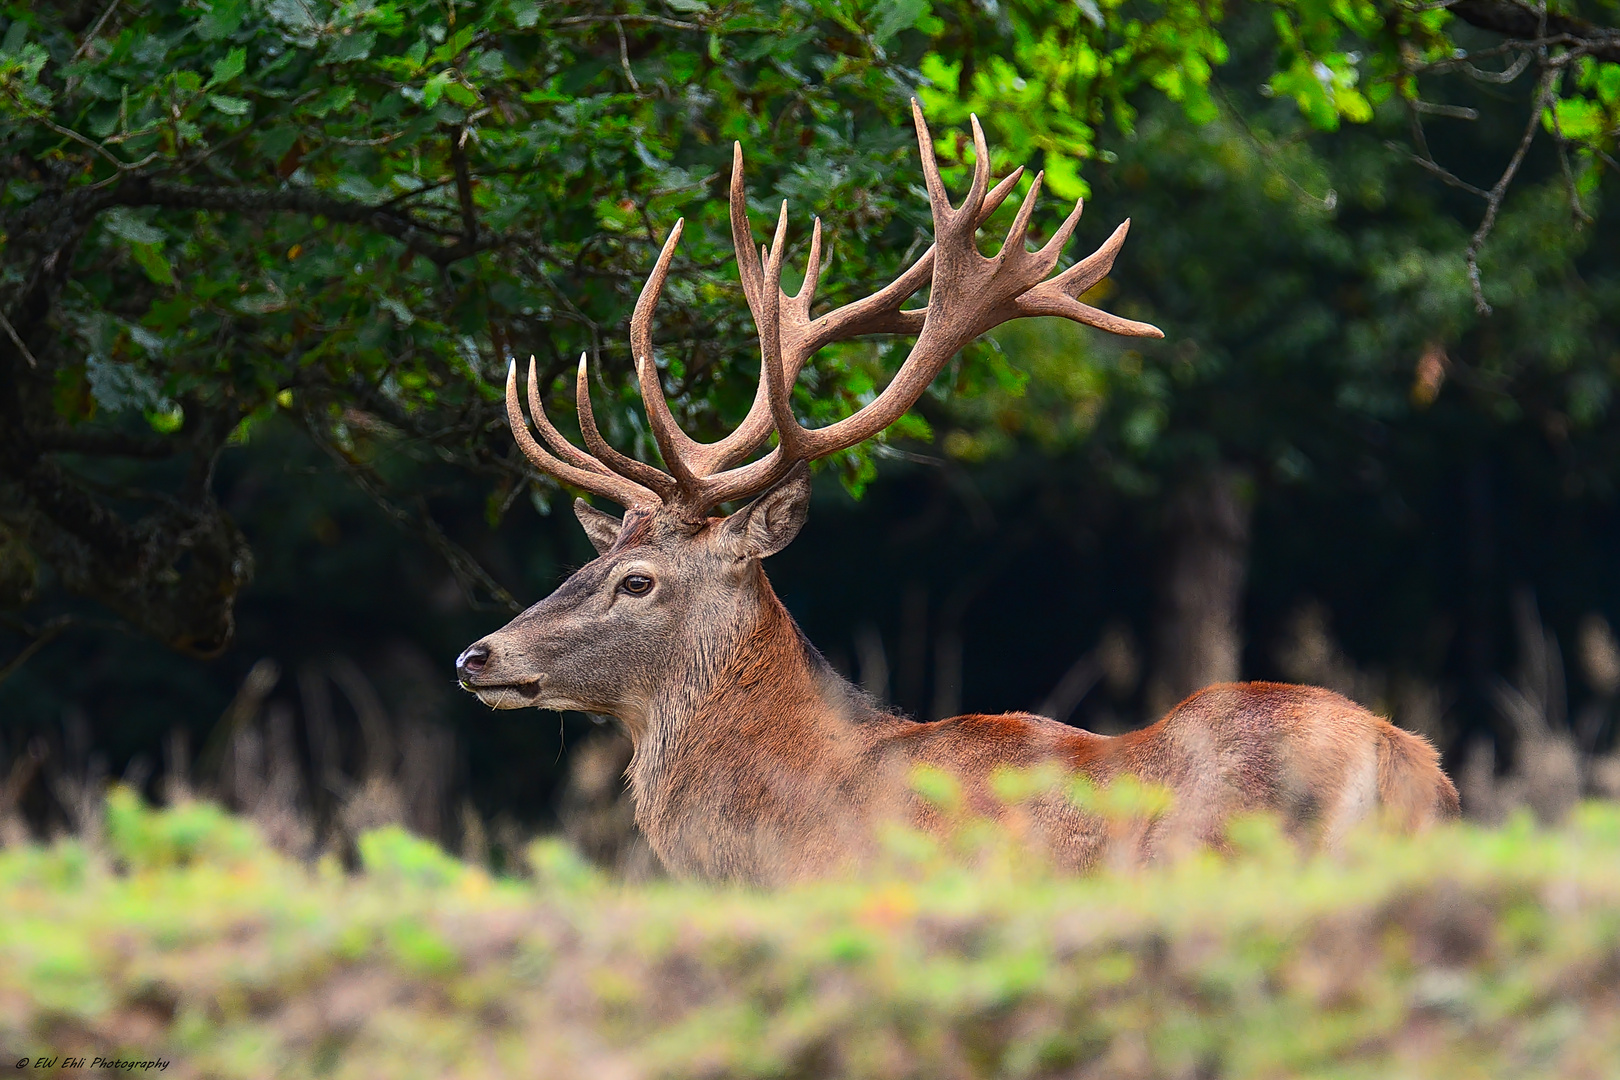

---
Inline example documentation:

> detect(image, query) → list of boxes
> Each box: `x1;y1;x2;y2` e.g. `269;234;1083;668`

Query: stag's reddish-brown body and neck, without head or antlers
630;572;1456;881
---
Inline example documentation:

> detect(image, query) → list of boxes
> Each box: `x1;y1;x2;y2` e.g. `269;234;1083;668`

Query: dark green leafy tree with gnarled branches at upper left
0;0;972;667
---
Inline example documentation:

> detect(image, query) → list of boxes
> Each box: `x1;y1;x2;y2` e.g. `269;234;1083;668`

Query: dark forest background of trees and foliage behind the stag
0;0;1620;845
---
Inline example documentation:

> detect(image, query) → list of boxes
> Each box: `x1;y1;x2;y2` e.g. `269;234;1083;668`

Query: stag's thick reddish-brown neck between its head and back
630;570;876;878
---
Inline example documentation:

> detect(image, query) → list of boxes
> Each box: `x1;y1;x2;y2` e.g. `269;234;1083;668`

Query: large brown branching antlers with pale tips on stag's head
507;100;1163;518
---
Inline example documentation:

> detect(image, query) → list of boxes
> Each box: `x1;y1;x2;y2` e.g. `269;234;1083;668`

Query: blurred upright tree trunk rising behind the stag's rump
1147;468;1254;719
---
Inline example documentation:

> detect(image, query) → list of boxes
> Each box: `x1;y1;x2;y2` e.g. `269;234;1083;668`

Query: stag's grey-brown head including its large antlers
457;102;1163;730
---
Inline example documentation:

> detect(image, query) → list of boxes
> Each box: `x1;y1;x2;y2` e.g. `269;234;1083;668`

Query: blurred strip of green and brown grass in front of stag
0;790;1620;1080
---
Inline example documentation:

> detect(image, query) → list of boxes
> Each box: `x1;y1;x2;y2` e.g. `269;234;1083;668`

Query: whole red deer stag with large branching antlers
457;102;1456;882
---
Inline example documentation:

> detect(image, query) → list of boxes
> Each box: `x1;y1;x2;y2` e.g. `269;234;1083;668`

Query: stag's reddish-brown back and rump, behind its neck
873;682;1456;865
